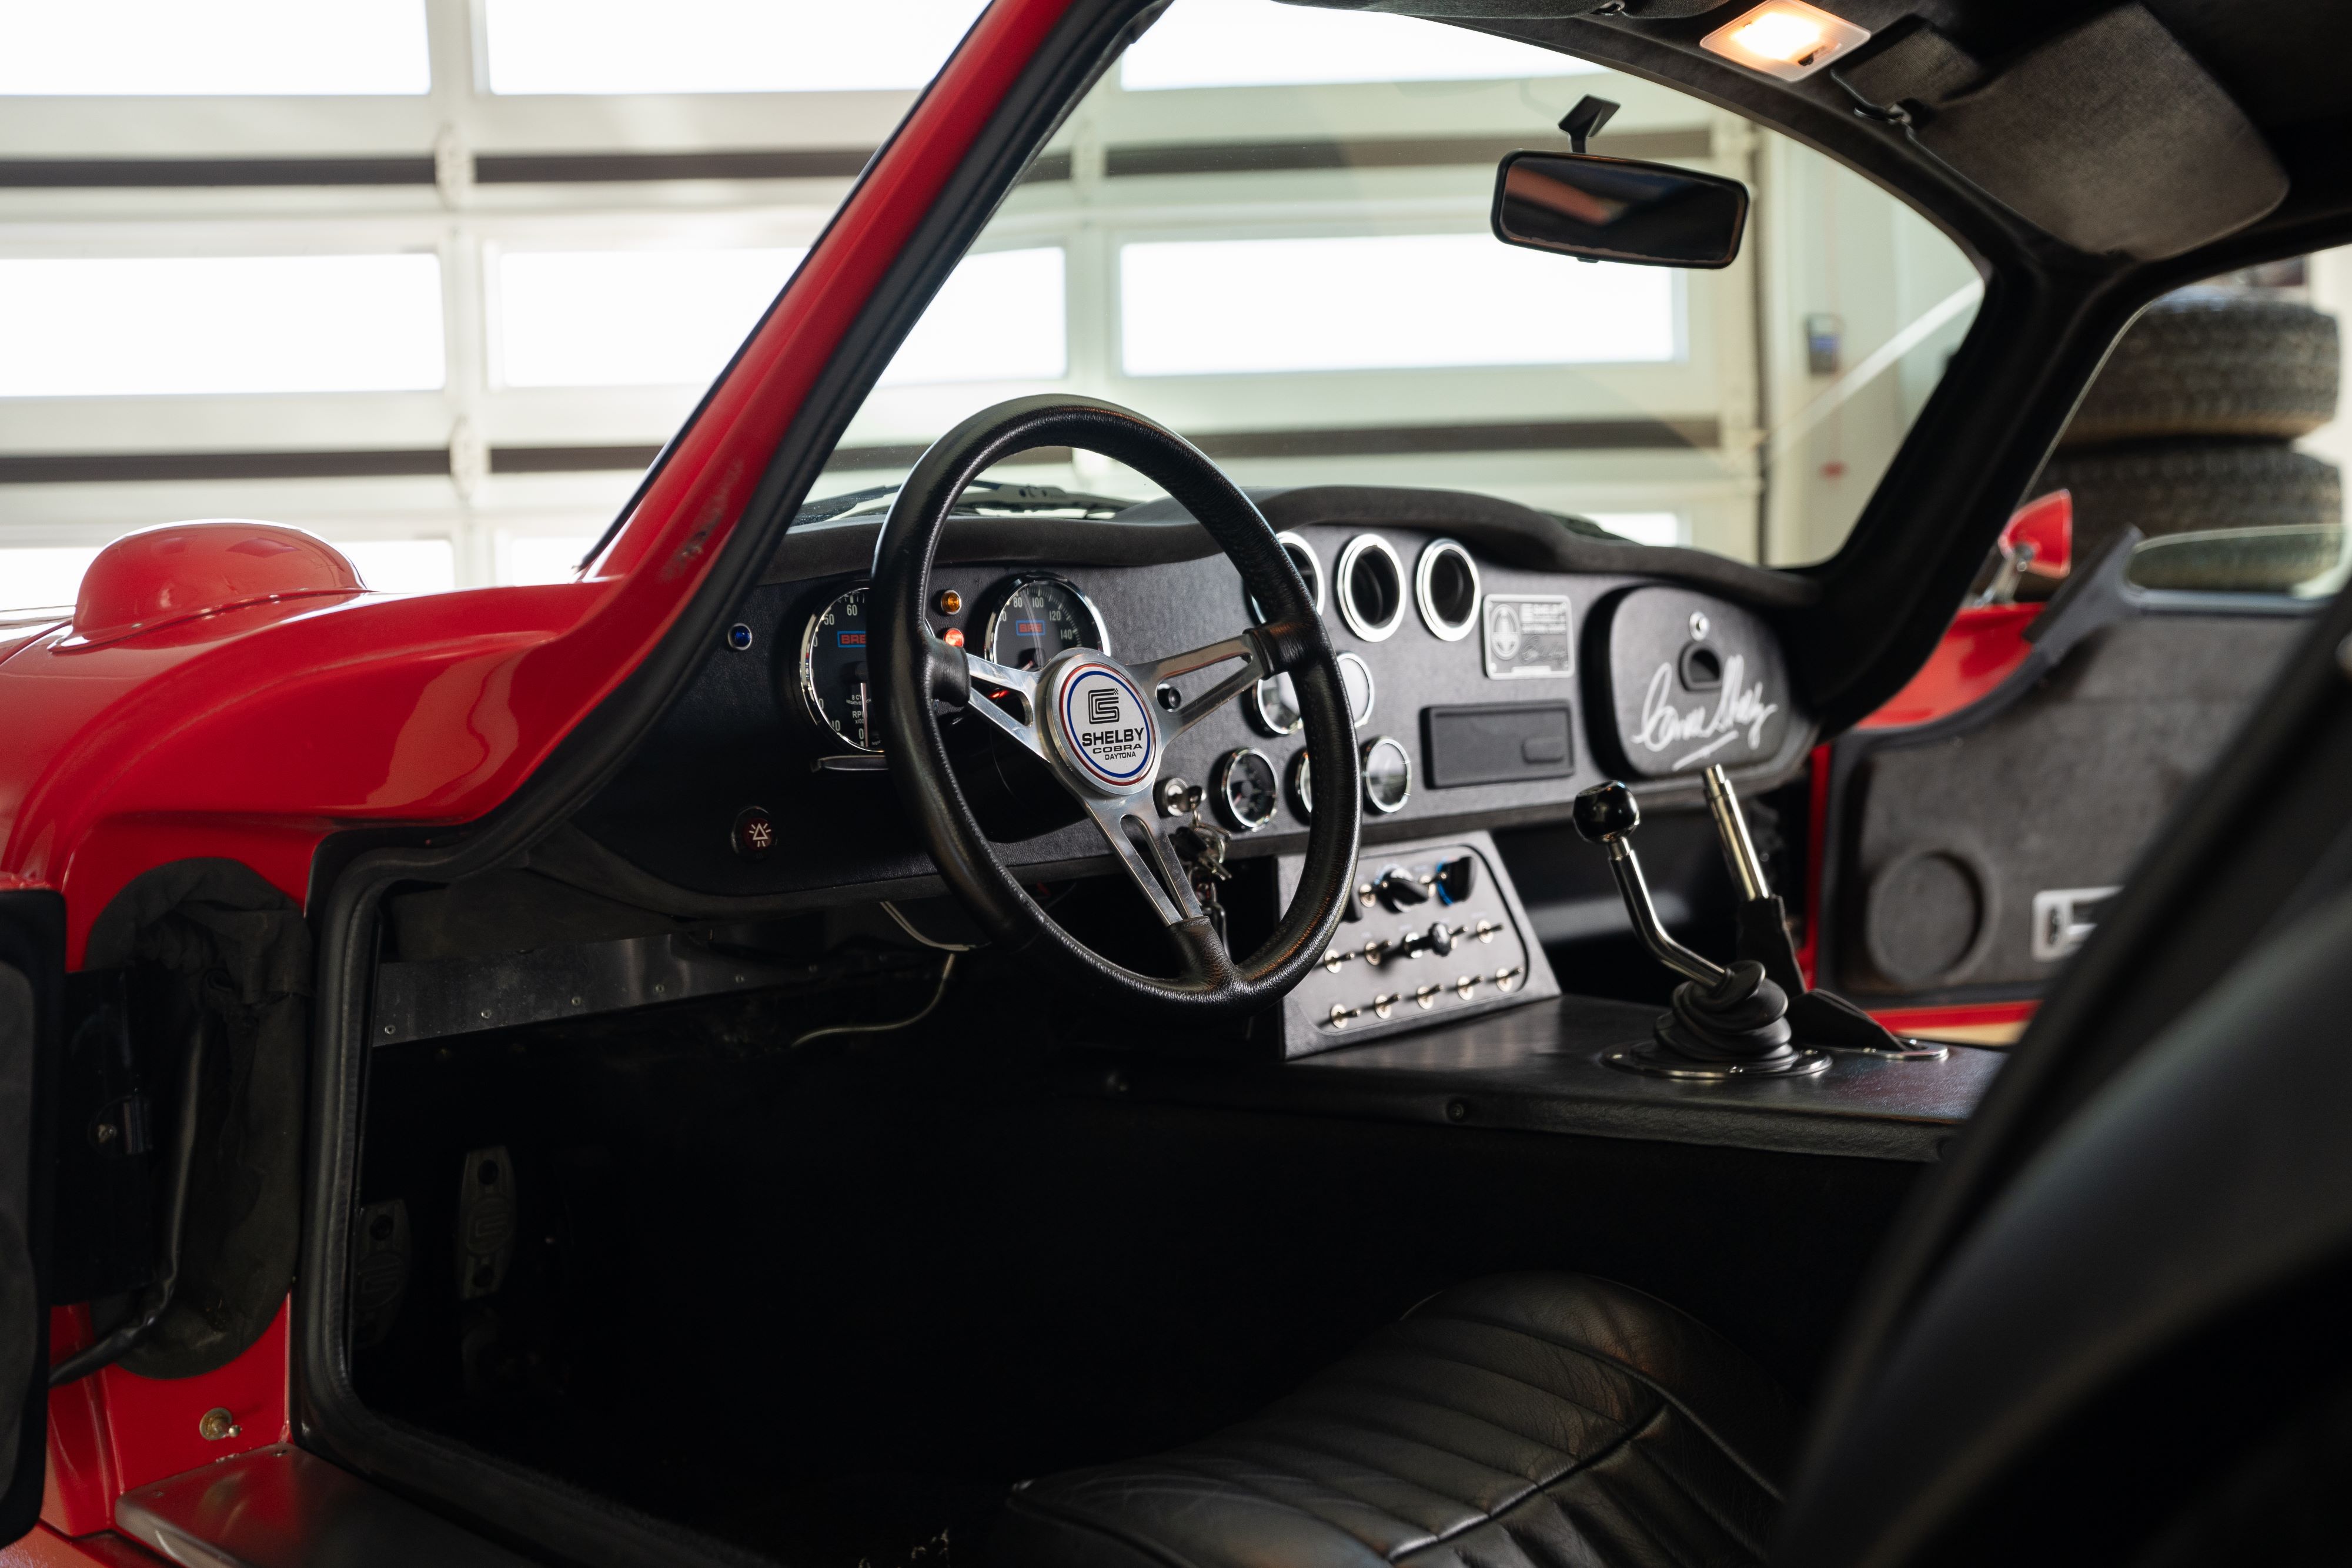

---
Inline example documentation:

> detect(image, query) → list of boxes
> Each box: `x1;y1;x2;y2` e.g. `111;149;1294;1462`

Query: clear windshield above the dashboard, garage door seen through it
814;0;1980;564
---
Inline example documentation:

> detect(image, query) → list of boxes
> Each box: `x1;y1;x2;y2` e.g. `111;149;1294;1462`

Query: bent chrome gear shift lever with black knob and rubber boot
1576;781;1830;1079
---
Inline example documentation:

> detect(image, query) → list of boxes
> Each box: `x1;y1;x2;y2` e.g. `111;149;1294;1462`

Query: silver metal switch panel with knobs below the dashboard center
1279;832;1559;1055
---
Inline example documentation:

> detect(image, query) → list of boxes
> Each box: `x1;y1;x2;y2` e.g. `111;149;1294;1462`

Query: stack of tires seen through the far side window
2030;287;2343;588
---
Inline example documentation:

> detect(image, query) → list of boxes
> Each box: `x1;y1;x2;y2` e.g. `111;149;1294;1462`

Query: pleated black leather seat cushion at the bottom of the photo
990;1274;1797;1568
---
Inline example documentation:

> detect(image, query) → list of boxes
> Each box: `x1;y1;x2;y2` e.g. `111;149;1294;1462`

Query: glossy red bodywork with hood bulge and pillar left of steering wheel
0;0;1065;1563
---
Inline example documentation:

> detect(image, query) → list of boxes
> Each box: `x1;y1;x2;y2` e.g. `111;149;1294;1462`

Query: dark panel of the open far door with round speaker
1820;609;2307;1006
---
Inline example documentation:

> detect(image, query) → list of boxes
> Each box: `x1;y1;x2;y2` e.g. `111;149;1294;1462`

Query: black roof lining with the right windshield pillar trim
1291;0;2352;734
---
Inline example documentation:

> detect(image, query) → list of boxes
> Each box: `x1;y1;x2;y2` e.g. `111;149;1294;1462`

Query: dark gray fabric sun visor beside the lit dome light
1832;5;2286;261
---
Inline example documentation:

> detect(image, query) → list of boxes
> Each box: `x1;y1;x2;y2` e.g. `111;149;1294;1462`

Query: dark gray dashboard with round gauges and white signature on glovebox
579;489;1813;905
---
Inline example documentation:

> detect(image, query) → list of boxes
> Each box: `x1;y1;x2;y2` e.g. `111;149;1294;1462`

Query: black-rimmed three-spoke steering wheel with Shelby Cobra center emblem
870;395;1362;1022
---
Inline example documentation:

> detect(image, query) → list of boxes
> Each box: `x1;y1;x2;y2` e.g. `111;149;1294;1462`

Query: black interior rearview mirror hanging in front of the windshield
1494;153;1748;268
